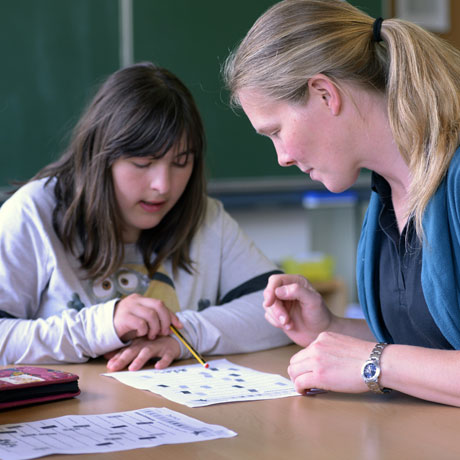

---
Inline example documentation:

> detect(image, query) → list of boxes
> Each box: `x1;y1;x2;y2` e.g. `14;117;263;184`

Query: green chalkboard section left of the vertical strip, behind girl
0;0;119;187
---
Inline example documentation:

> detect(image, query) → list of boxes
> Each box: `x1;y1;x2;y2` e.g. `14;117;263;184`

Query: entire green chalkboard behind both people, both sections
0;0;383;189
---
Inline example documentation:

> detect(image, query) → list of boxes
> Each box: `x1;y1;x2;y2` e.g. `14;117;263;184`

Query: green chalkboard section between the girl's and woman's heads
134;0;381;180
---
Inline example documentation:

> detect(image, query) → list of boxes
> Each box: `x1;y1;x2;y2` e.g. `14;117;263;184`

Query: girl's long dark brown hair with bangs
33;62;206;279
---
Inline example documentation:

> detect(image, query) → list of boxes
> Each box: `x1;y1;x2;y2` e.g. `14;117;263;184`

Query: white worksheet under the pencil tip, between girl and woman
103;359;299;407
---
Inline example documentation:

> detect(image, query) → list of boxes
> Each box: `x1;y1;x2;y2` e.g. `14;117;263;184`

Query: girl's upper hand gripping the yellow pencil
113;294;183;342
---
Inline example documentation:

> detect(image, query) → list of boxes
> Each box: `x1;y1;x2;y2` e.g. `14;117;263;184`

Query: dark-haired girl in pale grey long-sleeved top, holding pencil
0;63;289;370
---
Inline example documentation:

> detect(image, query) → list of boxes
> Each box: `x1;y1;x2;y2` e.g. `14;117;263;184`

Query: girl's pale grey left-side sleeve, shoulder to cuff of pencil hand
0;181;123;364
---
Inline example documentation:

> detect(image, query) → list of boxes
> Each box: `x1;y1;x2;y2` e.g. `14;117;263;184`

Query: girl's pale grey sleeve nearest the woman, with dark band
175;200;291;357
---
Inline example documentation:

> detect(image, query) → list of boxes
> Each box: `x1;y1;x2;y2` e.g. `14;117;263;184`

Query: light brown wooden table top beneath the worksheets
0;345;460;460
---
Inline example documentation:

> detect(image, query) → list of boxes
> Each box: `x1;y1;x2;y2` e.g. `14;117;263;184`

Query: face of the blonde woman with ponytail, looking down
238;90;360;193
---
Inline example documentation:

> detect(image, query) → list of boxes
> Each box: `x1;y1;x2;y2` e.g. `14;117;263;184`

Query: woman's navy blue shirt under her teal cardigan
372;173;453;350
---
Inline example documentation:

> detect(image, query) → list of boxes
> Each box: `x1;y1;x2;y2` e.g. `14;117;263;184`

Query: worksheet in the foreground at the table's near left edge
0;407;236;460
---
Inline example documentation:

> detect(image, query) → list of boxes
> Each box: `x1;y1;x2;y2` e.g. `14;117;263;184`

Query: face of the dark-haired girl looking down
112;143;194;243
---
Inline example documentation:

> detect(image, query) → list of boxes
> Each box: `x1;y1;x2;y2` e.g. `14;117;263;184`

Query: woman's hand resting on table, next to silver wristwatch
288;332;375;393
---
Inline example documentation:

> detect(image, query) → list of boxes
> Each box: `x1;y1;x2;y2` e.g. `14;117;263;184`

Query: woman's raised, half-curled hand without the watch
263;275;333;347
